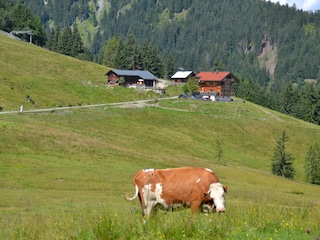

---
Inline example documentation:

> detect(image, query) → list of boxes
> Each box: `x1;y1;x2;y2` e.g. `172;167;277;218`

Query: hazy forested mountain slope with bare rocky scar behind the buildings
20;0;320;88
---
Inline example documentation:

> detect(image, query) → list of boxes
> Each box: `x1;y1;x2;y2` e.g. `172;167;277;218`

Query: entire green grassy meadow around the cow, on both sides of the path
0;32;320;240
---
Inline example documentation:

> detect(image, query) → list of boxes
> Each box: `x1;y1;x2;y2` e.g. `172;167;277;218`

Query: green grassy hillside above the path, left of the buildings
0;33;165;111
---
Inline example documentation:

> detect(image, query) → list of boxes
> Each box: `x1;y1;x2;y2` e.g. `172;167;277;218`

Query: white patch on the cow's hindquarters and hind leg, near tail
142;183;168;216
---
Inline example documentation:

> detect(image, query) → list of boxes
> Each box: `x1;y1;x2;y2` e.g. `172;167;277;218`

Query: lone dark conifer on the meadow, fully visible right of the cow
271;131;295;179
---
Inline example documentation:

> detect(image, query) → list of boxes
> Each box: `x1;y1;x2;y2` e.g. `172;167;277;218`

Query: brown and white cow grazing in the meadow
125;167;227;217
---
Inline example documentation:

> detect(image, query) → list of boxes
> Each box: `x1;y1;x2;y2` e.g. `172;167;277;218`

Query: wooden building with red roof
196;71;238;97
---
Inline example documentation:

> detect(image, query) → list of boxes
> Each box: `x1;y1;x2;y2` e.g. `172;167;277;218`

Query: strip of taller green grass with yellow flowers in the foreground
2;204;320;240
